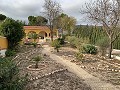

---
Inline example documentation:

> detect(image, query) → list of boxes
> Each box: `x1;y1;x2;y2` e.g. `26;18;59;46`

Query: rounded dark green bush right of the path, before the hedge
82;44;97;54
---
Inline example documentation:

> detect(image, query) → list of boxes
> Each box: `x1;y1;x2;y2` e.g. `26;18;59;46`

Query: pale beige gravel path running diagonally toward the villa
42;45;119;90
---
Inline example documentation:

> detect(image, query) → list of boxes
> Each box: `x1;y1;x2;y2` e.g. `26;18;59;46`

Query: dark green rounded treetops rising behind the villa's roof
28;16;48;26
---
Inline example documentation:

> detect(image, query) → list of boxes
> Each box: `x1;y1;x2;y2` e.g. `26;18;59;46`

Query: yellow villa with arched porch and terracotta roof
24;26;58;42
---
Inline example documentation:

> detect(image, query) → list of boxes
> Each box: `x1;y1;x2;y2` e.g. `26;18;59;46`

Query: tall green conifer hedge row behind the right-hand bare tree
73;25;120;49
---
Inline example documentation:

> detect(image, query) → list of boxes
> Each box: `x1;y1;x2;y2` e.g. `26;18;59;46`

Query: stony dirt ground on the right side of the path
53;47;120;88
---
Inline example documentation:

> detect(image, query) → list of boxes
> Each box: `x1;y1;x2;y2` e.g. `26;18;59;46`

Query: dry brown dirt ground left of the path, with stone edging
13;46;91;90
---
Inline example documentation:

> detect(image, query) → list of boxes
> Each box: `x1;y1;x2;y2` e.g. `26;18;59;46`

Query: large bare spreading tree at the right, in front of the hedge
81;0;120;58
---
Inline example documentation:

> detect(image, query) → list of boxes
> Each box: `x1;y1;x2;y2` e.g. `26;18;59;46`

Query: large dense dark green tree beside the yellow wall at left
2;18;25;49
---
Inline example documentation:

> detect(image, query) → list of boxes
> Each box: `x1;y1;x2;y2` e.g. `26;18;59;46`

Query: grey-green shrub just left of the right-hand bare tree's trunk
97;37;109;56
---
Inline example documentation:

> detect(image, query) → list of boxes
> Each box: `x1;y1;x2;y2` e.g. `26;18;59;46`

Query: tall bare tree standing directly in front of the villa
43;0;62;41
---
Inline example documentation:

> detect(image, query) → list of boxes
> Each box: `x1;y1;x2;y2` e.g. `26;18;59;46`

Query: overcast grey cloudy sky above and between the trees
0;0;89;24
